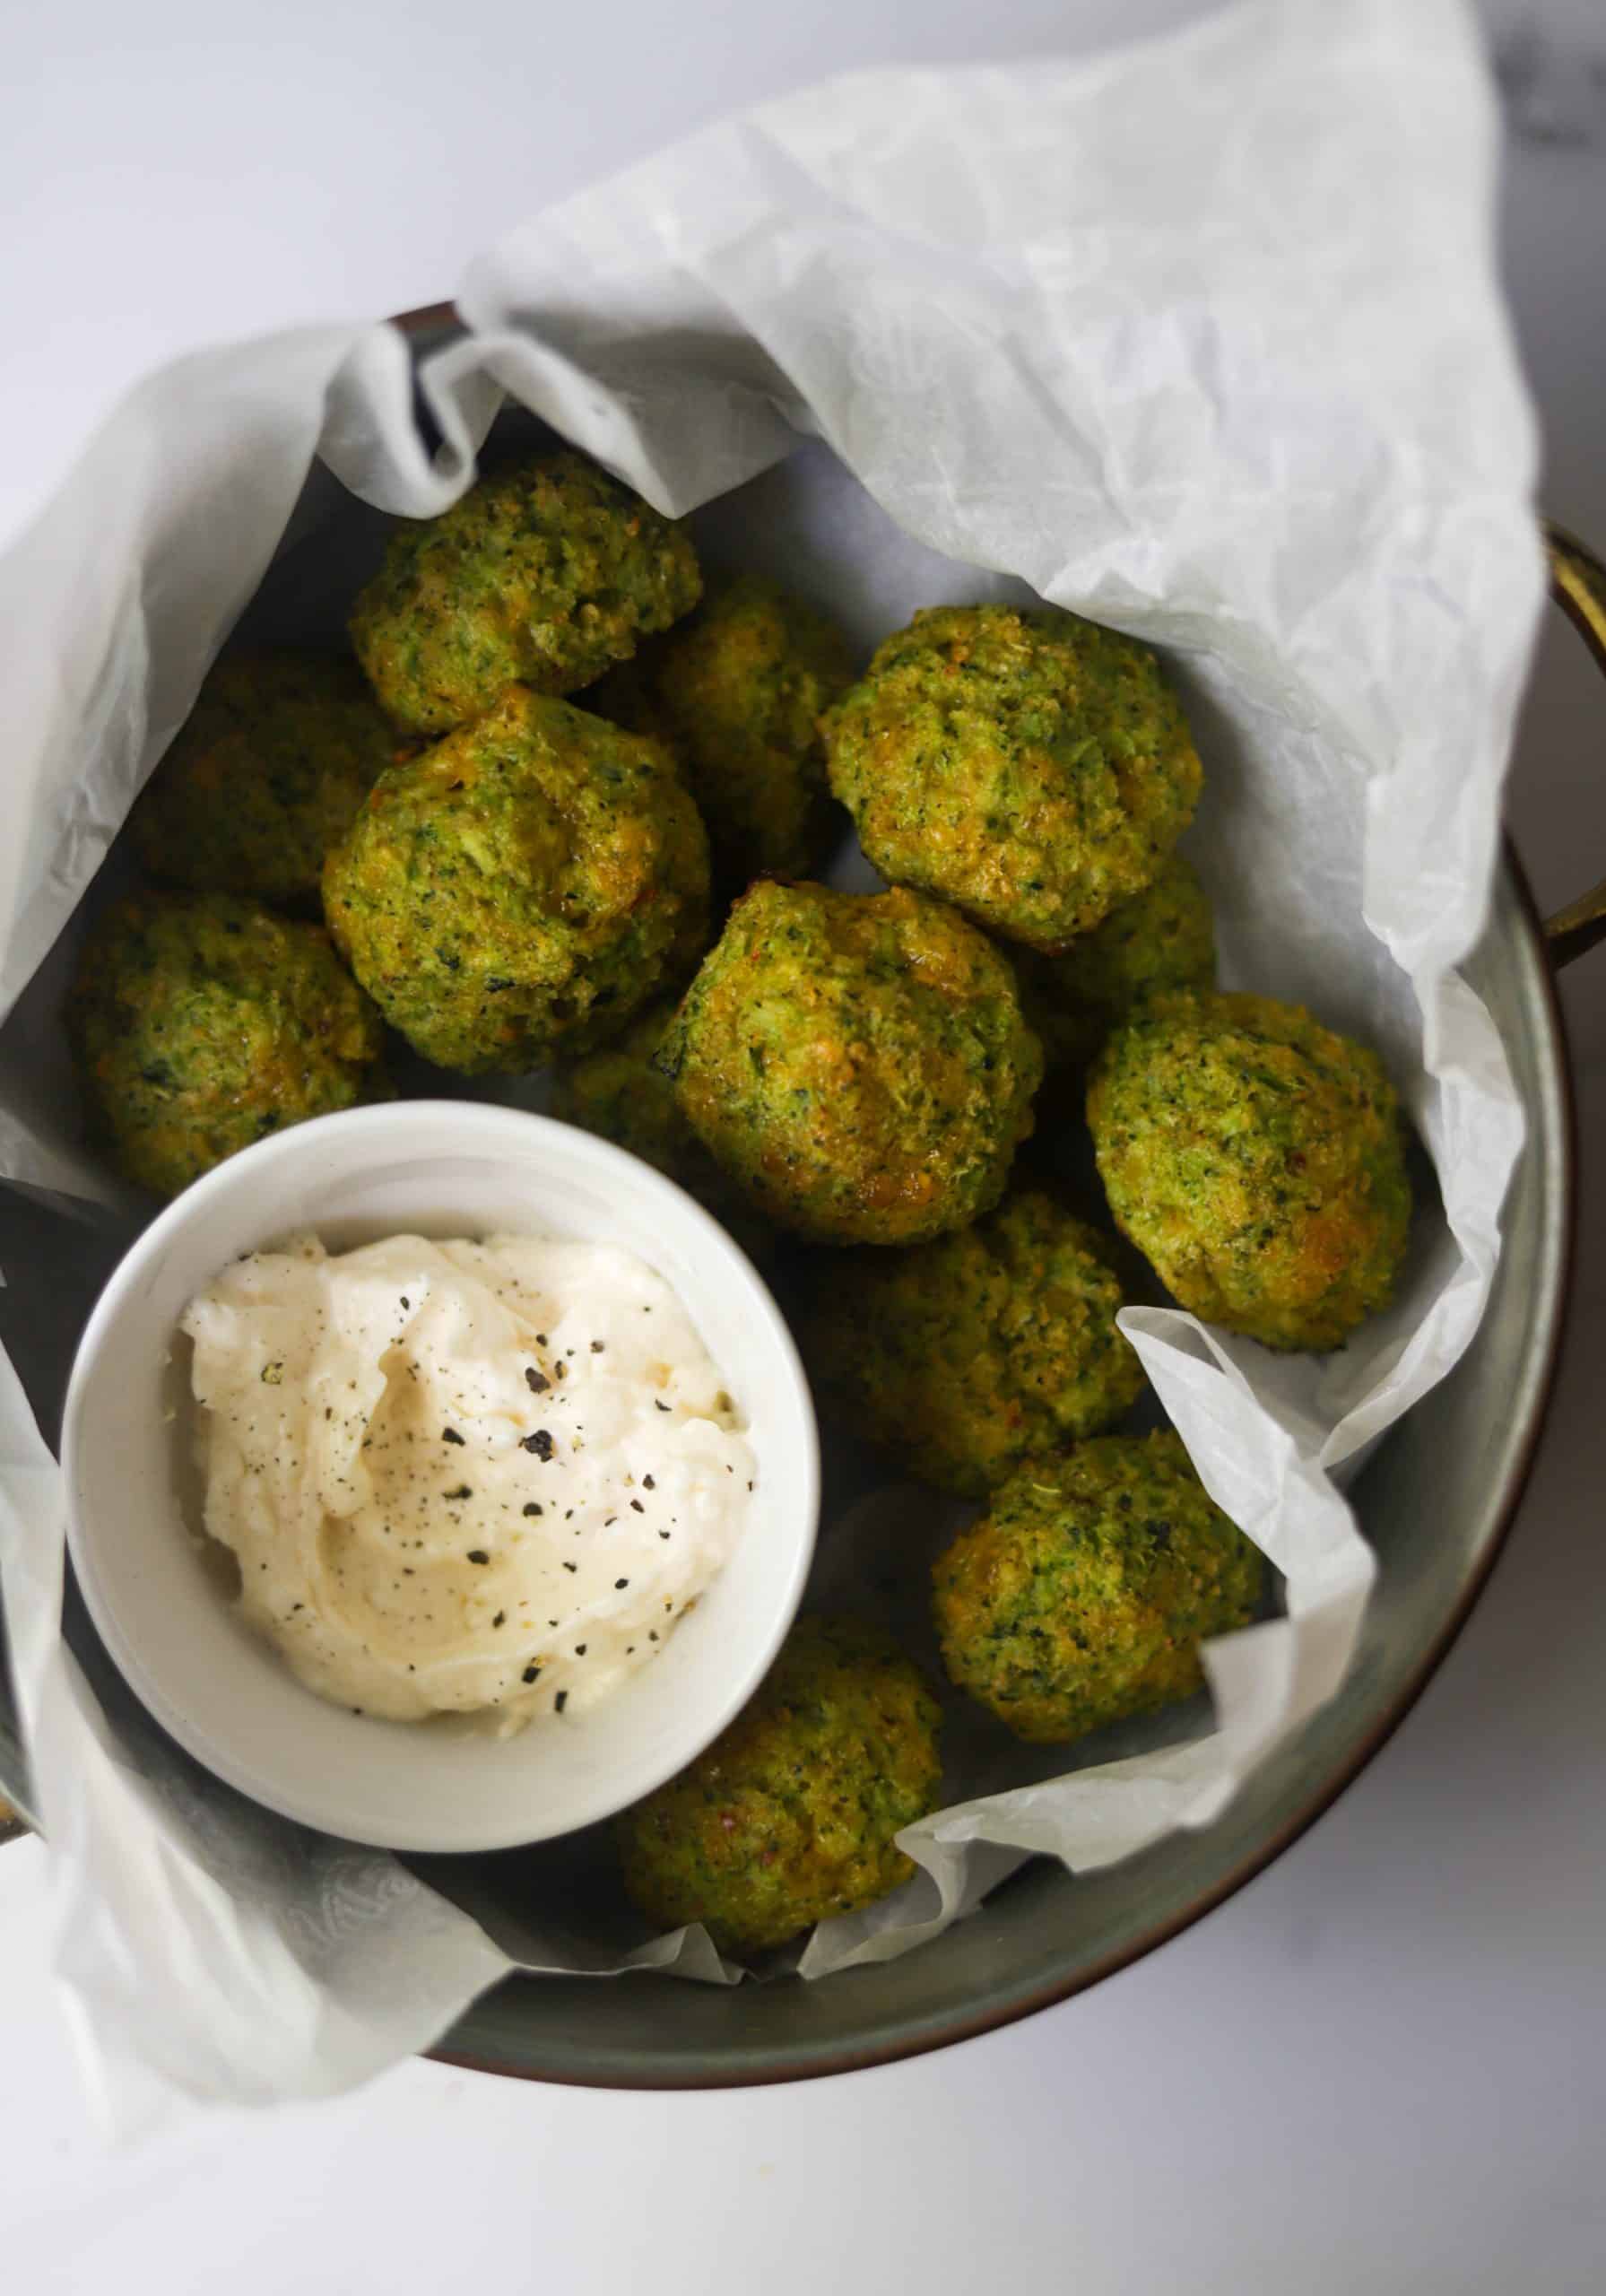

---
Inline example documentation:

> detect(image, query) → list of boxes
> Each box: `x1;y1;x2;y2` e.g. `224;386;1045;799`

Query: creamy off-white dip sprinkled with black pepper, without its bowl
184;1235;757;1731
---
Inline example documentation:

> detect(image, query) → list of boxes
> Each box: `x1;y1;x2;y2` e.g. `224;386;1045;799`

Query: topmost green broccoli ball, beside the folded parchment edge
351;455;702;735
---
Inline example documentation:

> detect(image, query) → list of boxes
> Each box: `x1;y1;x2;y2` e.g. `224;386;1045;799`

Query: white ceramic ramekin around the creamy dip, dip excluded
62;1100;819;1850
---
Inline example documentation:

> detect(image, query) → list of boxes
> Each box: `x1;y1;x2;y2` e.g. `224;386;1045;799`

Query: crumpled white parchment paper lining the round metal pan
0;0;1541;2112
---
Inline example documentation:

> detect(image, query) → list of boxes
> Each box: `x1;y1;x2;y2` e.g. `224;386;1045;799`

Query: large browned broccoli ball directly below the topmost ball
324;686;709;1074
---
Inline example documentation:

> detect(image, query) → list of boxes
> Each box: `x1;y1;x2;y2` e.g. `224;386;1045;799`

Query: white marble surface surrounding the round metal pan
0;0;1606;2296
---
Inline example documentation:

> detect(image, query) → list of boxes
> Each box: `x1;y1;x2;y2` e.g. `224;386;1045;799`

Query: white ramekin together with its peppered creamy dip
62;1100;819;1850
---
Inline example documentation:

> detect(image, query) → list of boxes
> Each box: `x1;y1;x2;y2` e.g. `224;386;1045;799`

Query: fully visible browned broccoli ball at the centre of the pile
663;879;1042;1245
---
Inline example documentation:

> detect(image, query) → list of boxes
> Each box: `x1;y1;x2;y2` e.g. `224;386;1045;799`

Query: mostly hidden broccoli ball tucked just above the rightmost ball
1014;854;1216;1067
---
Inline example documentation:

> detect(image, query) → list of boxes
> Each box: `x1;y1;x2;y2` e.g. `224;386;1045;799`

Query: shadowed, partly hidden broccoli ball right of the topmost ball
649;578;854;884
